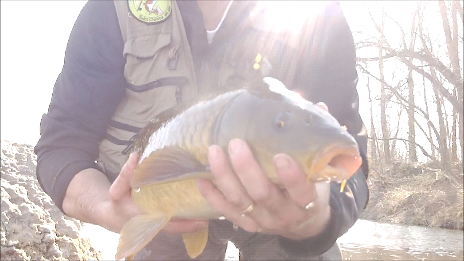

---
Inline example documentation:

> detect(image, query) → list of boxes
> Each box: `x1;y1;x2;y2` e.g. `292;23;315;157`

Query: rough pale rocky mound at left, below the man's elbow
0;140;101;260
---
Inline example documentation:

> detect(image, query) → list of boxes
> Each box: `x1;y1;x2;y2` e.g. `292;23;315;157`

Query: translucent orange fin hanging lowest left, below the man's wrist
116;213;171;260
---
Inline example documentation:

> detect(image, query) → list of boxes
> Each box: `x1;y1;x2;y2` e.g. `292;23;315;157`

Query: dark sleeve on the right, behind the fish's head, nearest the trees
279;2;369;256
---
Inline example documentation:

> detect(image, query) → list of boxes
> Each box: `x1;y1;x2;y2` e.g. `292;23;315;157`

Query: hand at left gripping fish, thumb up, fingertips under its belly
106;153;208;233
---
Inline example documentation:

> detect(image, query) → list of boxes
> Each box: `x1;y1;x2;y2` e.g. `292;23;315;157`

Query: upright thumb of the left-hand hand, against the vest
109;152;139;201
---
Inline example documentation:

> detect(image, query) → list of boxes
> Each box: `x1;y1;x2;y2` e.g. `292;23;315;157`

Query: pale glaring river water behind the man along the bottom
83;220;464;260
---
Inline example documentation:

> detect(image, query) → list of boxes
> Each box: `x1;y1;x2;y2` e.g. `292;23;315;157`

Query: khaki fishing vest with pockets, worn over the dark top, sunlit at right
97;0;330;182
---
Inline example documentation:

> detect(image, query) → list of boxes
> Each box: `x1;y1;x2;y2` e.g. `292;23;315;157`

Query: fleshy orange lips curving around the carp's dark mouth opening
308;144;361;182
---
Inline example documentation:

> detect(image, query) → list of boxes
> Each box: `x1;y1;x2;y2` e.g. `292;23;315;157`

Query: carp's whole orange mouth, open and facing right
308;145;362;182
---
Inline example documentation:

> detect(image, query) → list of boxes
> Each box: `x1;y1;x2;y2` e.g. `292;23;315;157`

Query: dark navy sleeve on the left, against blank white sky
35;1;125;210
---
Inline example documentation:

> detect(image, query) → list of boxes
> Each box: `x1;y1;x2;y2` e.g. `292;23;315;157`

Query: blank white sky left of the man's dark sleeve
1;0;86;145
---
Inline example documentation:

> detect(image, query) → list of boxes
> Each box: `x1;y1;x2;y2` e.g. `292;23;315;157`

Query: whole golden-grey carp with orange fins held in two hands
116;77;361;260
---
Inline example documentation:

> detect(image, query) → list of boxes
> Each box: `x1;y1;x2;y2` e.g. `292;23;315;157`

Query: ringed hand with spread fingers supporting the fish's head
198;103;352;240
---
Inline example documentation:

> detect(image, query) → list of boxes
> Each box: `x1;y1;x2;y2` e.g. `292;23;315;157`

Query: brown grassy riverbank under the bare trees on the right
361;160;463;230
